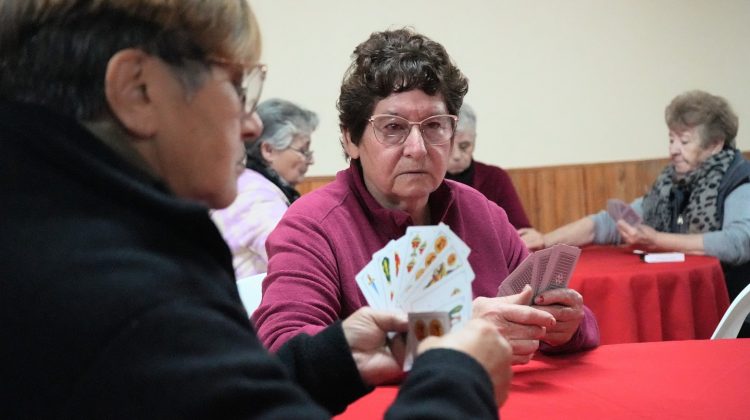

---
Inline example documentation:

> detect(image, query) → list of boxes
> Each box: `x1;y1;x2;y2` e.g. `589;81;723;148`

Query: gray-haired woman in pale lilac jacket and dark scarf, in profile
212;99;318;279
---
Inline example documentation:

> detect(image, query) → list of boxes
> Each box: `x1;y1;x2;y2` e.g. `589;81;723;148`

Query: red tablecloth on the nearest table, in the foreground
338;339;750;420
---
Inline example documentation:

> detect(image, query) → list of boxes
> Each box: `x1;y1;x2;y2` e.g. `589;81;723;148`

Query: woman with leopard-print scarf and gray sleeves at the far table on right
538;91;750;299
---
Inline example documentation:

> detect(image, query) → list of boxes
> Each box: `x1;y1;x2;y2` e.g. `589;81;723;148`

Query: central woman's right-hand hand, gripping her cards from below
532;289;584;346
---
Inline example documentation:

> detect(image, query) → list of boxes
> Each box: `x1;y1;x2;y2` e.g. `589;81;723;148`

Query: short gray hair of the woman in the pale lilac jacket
246;98;318;161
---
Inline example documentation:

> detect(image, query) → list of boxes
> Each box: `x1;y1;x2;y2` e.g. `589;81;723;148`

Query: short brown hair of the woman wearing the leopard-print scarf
664;90;739;149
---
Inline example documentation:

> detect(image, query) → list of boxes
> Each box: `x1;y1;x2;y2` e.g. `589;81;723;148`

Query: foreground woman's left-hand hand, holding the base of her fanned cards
342;306;409;386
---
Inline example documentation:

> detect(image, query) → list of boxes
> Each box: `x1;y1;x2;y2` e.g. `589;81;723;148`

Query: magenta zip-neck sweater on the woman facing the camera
252;163;598;350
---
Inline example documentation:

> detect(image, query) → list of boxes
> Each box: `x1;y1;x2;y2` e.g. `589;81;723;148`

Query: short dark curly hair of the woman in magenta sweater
336;28;469;144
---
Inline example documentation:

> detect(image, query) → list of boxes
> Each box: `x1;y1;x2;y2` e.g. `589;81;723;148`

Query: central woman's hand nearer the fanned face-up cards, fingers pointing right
472;285;555;364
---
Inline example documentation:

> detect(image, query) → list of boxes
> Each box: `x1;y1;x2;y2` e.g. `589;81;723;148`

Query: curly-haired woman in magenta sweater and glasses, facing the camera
253;29;599;363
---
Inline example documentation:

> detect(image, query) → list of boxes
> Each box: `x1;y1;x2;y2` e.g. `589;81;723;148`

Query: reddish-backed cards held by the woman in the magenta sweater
497;244;581;303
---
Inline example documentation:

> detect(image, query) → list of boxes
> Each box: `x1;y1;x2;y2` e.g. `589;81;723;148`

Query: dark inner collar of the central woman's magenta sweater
339;159;455;236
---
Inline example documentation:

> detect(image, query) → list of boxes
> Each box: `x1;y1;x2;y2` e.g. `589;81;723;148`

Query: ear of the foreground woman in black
104;48;157;138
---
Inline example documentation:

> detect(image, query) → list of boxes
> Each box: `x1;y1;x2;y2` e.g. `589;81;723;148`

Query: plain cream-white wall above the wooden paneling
250;0;750;175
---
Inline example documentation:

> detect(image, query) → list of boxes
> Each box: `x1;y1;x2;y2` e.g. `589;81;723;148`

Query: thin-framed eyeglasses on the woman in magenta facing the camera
367;114;458;146
